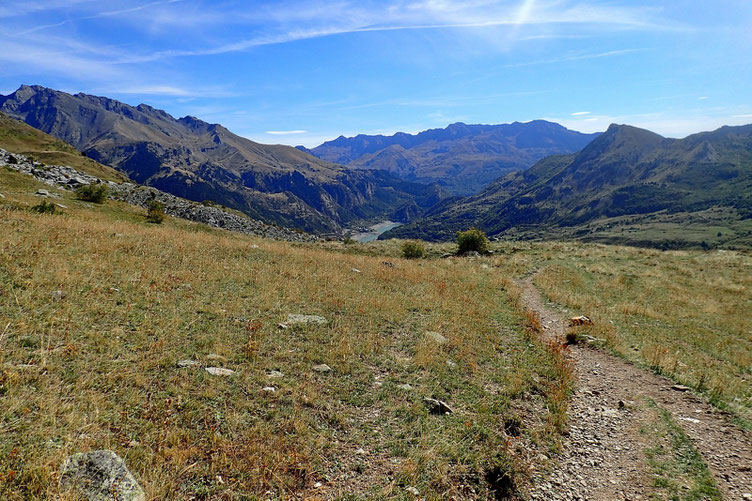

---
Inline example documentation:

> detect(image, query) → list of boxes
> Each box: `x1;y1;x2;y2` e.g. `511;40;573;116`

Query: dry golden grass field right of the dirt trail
524;244;752;426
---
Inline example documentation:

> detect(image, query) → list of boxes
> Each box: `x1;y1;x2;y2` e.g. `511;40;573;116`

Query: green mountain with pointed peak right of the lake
384;125;752;244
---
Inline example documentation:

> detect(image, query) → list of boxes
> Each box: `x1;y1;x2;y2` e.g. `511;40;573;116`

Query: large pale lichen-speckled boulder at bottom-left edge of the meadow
60;450;146;501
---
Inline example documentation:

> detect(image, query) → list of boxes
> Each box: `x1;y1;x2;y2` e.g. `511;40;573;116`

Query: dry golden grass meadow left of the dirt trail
0;172;568;499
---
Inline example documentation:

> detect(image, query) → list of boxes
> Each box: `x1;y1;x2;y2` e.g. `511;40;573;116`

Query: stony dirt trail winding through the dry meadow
518;278;752;500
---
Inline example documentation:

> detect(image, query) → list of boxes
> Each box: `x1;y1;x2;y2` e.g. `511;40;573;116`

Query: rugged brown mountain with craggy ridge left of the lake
0;86;441;232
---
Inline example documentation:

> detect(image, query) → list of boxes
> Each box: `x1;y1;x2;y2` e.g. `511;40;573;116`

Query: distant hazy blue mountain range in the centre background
310;120;598;195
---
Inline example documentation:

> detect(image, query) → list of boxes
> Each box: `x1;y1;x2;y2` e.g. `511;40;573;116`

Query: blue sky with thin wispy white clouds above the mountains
0;0;752;146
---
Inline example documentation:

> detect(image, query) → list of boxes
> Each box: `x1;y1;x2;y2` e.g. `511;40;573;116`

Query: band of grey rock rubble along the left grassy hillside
0;149;319;242
